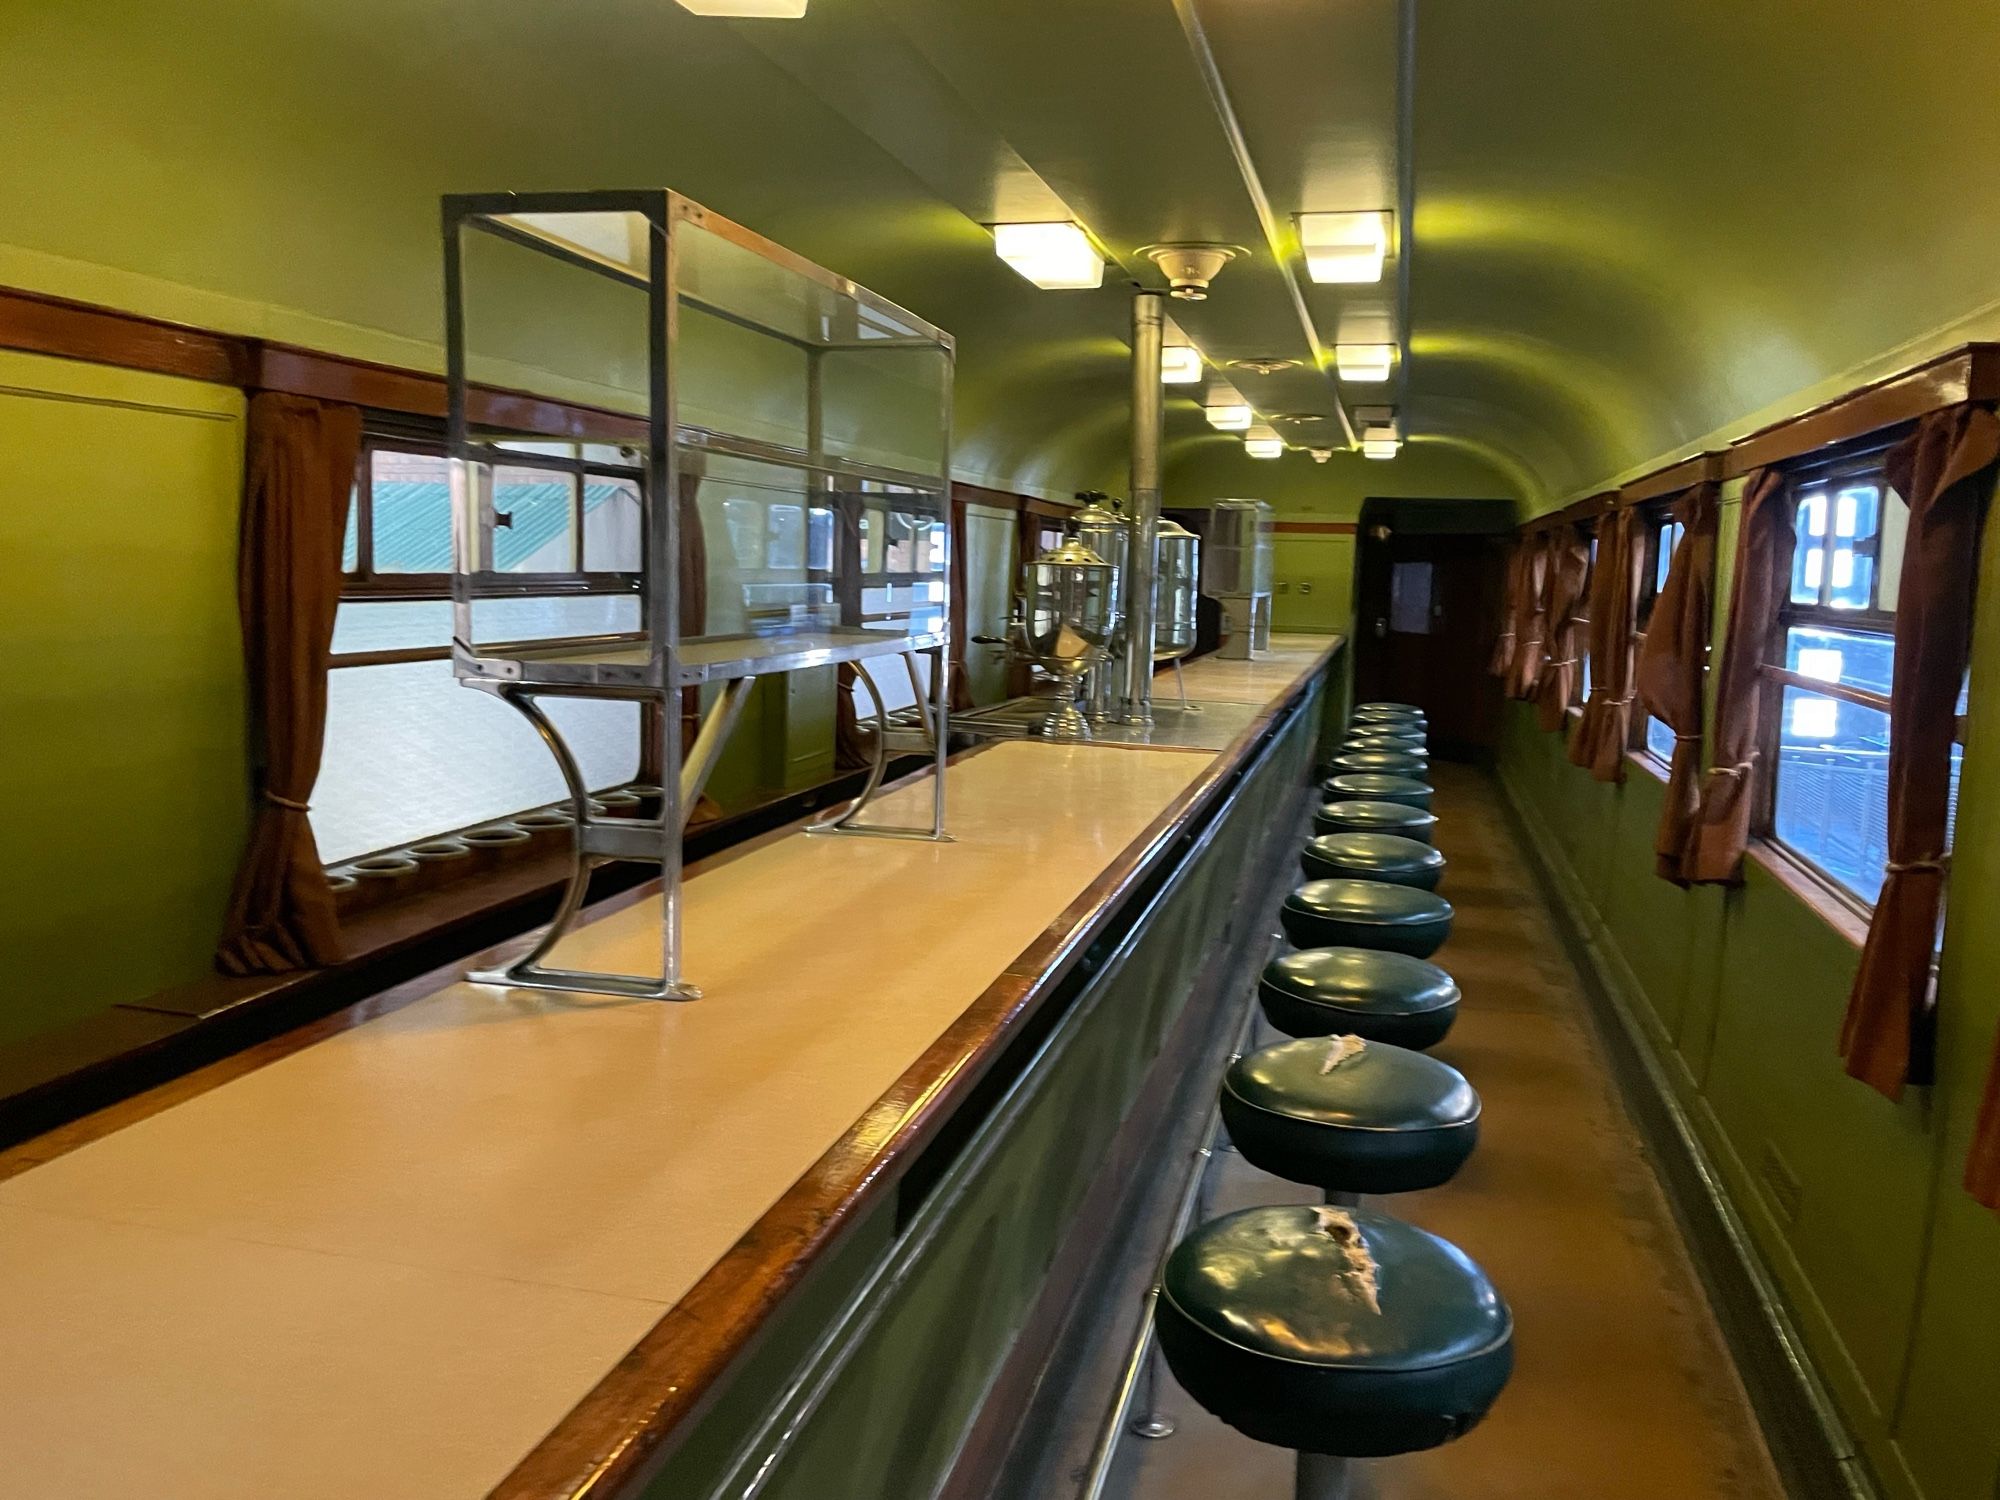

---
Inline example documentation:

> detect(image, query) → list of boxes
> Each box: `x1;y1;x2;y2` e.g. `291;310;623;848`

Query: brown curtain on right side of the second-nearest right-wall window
1638;484;1720;886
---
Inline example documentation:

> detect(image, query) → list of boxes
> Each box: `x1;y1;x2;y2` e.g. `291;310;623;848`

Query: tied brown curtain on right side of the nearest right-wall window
1840;406;2000;1112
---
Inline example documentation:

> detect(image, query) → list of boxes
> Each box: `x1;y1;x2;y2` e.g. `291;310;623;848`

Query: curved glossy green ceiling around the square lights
0;0;2000;504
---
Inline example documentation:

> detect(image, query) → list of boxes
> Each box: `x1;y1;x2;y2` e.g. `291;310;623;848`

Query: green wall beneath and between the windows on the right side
1500;488;2000;1500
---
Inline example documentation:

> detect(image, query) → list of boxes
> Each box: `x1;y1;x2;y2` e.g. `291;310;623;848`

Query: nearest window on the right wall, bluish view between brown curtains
1762;448;1964;906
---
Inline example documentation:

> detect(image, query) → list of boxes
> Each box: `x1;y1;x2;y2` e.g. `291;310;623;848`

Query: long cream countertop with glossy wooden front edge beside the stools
0;640;1338;1500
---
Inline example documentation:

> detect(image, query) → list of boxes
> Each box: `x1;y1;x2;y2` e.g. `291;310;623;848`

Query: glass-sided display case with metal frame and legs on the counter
444;188;954;1000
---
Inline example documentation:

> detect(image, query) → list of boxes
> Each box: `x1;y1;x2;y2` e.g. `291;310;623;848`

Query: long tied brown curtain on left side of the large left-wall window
216;392;362;974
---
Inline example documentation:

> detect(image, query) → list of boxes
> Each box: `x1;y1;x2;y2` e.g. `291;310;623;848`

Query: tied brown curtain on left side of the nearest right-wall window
1680;468;1798;886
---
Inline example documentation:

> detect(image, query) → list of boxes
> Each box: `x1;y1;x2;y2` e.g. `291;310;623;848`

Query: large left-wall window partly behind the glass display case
312;428;644;864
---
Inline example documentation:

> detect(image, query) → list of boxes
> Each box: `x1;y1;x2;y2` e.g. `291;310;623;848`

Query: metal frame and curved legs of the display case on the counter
442;188;956;1000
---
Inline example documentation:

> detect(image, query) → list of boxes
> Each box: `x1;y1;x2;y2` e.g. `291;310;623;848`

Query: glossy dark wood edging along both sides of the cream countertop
0;636;1346;1500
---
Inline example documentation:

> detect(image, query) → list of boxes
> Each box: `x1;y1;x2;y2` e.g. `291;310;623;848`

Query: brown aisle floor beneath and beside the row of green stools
1108;766;1782;1500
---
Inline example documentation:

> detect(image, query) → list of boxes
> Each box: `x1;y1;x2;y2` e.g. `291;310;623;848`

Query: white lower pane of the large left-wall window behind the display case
312;662;638;864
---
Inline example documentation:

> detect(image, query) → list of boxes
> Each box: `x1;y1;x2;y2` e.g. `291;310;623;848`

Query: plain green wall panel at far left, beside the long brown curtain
0;352;248;1042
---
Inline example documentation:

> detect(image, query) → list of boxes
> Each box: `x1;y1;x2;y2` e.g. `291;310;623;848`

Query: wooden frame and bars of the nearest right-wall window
1750;426;1966;924
